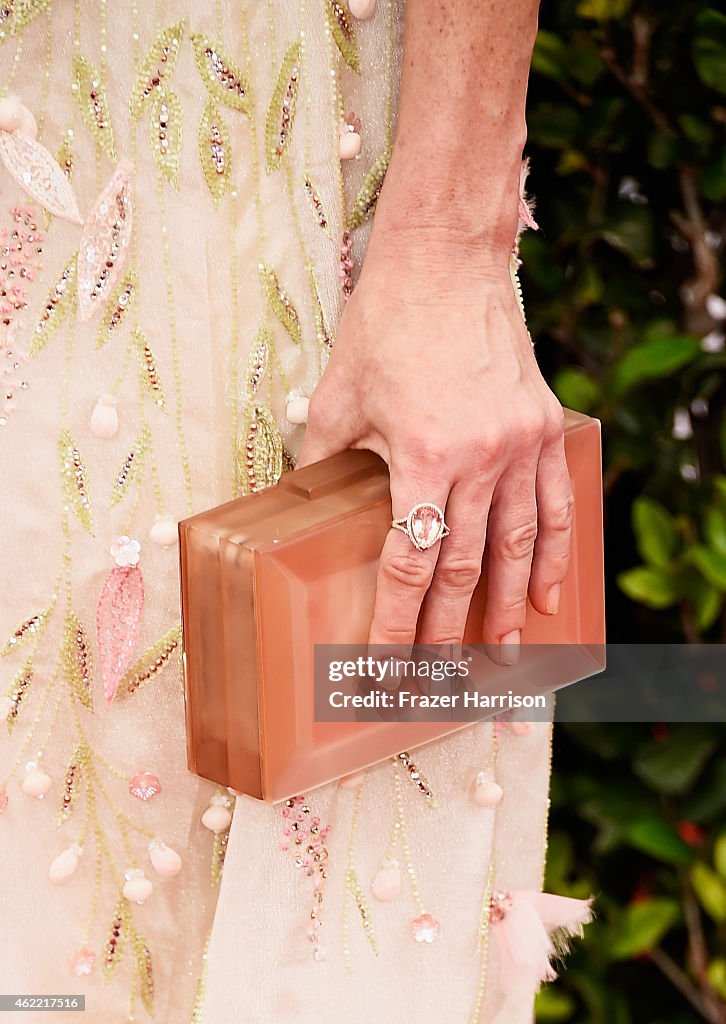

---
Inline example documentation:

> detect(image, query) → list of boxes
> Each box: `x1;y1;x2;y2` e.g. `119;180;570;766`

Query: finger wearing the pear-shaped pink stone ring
369;463;449;647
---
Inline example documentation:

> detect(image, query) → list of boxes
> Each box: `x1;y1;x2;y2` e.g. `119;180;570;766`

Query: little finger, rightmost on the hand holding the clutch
529;421;574;615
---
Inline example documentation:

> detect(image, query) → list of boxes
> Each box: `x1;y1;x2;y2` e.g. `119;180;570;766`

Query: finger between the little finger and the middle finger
483;445;539;665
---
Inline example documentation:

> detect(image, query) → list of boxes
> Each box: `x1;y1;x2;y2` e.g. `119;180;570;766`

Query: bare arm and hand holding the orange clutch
301;0;572;664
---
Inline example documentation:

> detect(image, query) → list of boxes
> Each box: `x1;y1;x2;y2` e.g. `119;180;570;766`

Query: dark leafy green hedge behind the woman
521;0;726;1024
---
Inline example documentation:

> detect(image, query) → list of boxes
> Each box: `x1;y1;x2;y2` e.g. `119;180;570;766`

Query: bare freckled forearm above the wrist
372;0;539;261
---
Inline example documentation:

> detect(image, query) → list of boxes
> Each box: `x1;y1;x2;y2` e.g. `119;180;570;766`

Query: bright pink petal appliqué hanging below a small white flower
96;565;143;708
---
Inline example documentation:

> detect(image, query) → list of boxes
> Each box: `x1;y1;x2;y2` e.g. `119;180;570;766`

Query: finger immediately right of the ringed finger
419;477;493;644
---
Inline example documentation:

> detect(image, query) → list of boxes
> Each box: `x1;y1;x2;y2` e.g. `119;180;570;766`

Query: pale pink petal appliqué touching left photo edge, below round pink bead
0;131;83;224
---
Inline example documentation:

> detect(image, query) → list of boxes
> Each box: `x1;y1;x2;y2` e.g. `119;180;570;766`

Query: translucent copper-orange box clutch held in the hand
179;412;604;802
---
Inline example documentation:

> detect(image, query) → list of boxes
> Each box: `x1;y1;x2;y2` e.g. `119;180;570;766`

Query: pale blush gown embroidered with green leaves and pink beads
0;0;565;1024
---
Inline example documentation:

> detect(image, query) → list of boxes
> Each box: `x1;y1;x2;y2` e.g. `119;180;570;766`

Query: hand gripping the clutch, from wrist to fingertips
300;232;572;664
